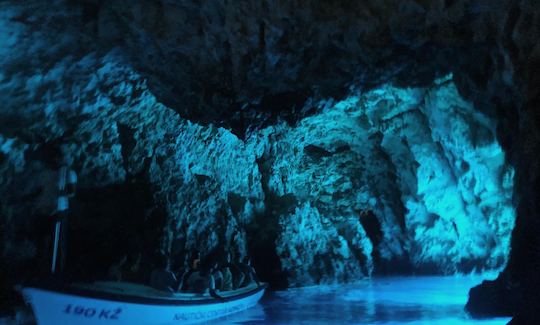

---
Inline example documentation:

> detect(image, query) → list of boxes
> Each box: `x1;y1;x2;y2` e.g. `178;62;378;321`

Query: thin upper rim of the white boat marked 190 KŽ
23;283;268;306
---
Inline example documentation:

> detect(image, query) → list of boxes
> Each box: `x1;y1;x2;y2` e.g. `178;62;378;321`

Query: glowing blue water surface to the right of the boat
211;276;510;325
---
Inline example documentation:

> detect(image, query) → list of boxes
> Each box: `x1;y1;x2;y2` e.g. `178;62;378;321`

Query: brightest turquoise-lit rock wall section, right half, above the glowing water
259;76;515;284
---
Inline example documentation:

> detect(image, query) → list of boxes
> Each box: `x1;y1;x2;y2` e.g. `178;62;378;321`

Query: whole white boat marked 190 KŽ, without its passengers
22;282;267;325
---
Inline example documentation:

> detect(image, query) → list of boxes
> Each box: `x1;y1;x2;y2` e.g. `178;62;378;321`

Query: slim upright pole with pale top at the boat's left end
51;166;77;274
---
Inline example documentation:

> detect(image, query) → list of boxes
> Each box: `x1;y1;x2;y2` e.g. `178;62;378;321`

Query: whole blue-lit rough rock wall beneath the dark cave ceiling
2;31;514;285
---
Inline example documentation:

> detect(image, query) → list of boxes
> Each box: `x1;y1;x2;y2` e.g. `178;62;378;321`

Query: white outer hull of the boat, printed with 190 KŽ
23;288;264;325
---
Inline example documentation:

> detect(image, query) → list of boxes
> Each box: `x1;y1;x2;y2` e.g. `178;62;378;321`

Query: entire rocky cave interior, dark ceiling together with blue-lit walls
0;0;540;321
